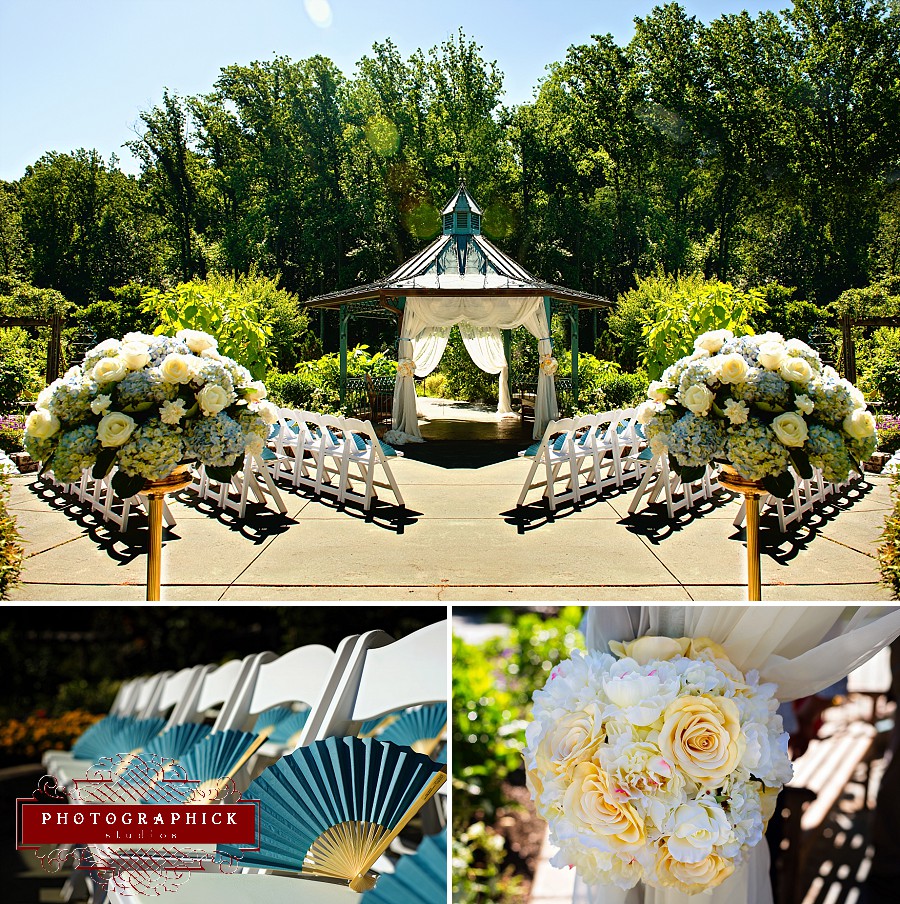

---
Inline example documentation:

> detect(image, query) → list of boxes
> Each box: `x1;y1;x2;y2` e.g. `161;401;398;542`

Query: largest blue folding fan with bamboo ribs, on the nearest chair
217;738;447;891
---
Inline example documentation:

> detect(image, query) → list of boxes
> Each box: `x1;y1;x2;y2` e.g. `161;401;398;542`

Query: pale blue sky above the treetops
0;0;772;179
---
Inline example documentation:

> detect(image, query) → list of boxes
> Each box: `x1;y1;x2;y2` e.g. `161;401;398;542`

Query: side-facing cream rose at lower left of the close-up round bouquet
563;762;647;847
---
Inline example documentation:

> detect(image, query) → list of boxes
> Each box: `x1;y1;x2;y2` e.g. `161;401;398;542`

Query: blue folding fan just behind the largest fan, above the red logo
144;730;268;804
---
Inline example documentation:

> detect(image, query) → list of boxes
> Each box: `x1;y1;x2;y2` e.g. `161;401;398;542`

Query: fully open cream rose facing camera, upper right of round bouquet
659;694;745;788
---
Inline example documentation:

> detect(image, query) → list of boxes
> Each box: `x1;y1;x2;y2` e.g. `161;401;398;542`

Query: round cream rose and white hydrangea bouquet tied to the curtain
525;636;791;894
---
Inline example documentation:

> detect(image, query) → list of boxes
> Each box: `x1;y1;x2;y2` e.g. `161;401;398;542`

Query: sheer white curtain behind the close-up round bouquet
574;606;900;904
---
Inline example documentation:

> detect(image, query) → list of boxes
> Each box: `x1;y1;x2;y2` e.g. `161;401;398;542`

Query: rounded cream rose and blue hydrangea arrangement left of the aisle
24;330;278;498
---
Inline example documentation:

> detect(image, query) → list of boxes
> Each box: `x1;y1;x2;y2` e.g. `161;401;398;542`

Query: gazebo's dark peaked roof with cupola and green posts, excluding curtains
304;185;615;400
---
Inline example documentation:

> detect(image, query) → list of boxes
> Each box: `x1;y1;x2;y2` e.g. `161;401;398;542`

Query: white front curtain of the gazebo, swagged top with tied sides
388;296;559;444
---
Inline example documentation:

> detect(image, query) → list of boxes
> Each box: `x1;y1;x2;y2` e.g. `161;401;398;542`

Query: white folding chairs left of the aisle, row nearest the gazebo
265;408;404;511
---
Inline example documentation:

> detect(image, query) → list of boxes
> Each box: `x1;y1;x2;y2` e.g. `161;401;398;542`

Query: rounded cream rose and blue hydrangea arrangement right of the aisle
638;330;877;497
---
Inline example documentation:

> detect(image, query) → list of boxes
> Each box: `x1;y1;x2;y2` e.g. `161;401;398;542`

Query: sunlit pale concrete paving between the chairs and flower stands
10;459;890;602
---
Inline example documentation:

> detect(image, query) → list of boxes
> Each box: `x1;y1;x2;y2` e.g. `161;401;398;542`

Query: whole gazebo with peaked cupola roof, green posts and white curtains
306;184;613;443
